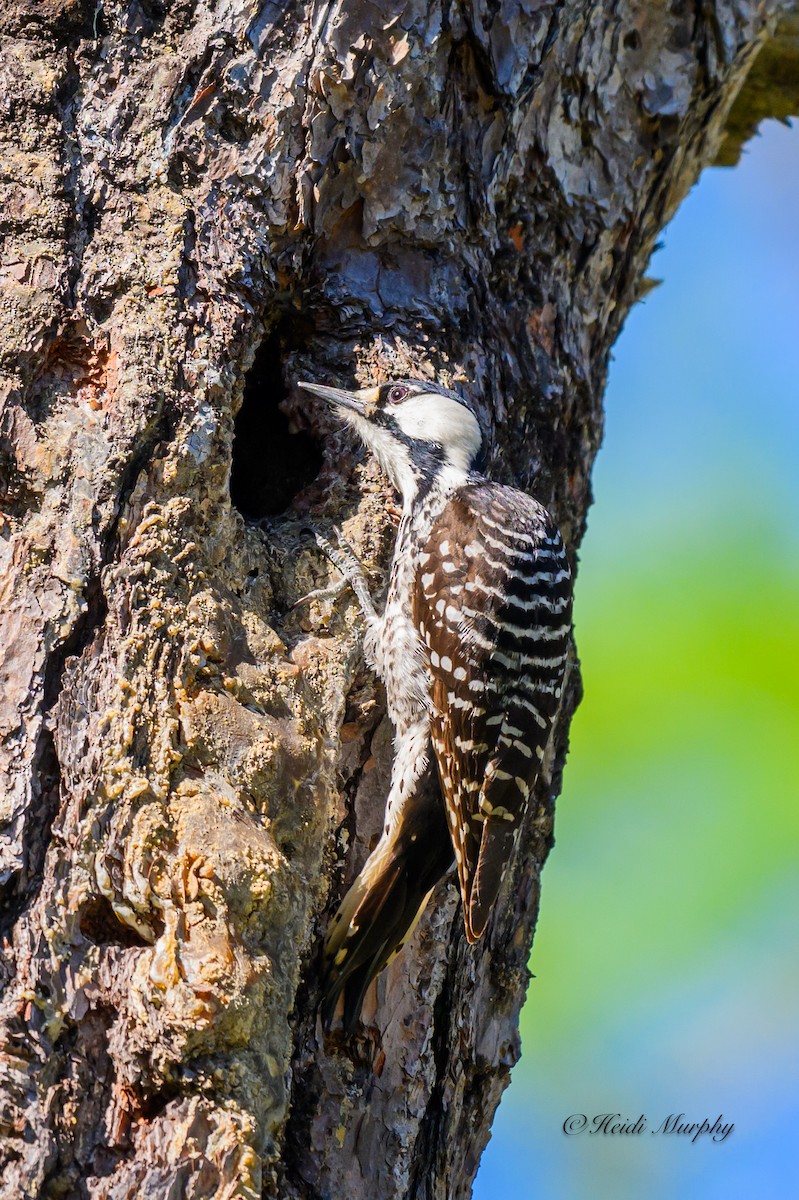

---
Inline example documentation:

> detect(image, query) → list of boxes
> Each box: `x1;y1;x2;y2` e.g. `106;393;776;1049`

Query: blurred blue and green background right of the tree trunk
474;121;799;1200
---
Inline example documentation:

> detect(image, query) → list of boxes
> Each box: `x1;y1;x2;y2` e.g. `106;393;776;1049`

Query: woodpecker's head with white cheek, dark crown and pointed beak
300;379;482;500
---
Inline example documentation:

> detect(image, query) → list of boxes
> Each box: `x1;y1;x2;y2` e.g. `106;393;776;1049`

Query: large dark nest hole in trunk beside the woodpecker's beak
230;330;323;520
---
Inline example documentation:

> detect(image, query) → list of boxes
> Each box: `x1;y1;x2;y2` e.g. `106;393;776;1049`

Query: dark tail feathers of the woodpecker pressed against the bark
320;773;452;1033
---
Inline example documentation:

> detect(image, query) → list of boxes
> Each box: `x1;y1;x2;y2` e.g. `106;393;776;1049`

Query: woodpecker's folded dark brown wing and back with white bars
414;484;571;941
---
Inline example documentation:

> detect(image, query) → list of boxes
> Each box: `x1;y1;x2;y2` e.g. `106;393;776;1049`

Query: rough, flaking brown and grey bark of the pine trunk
0;0;777;1200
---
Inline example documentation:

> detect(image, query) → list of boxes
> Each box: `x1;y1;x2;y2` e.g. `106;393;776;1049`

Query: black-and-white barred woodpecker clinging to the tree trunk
300;379;571;1032
